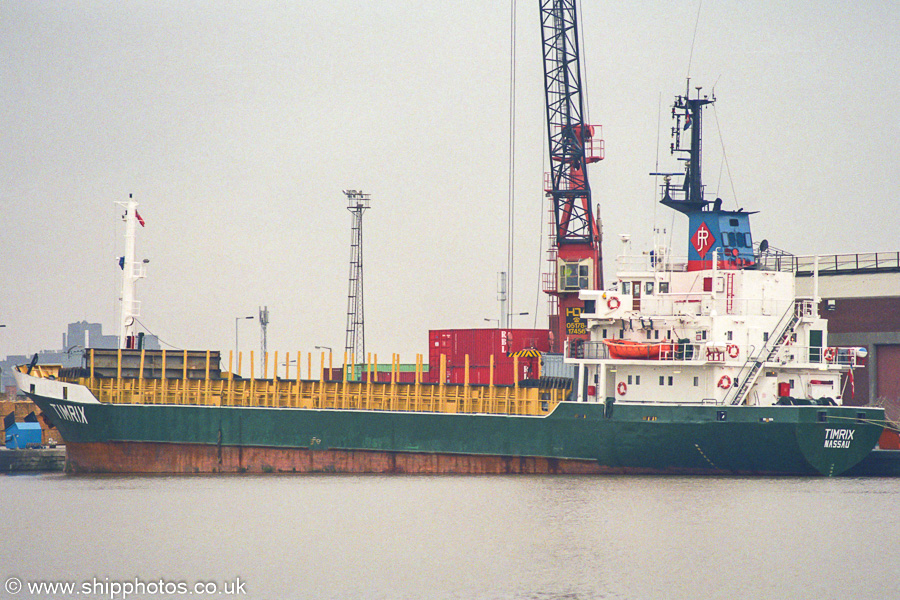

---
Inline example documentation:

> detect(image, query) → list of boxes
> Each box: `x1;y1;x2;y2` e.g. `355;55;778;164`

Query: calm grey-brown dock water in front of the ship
0;474;900;600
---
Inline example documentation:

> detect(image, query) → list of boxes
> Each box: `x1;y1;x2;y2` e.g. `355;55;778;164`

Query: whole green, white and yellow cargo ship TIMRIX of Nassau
15;77;885;476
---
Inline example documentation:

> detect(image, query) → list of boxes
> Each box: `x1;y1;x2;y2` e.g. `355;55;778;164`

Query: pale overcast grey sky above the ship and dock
0;0;900;362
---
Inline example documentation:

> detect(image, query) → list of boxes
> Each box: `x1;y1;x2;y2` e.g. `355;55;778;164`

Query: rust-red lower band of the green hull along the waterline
66;442;623;475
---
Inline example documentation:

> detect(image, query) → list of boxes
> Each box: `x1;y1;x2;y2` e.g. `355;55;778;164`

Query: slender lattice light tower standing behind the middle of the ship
344;190;369;380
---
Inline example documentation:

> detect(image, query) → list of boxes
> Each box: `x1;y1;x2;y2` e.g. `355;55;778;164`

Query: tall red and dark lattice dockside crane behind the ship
540;0;604;352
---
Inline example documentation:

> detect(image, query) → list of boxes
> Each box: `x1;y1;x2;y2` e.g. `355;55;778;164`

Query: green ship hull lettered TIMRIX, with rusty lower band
27;393;884;476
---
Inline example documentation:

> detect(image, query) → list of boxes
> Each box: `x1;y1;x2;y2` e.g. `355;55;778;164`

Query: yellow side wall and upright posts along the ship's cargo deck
52;349;568;416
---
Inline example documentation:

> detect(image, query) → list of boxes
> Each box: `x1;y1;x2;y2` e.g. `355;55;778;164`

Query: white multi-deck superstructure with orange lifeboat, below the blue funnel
567;251;862;405
